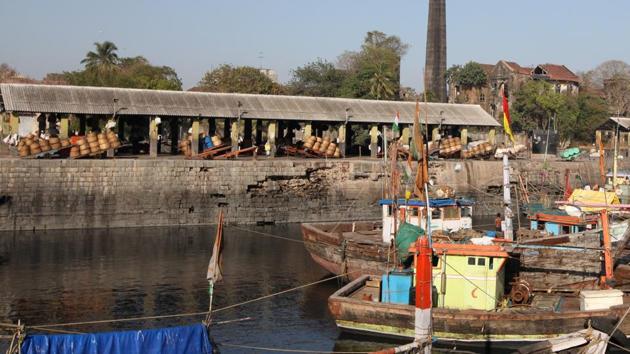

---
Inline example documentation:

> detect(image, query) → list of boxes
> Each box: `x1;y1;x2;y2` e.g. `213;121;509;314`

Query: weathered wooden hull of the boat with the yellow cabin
328;276;630;342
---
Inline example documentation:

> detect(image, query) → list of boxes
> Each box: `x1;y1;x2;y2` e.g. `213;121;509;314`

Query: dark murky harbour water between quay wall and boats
0;225;410;353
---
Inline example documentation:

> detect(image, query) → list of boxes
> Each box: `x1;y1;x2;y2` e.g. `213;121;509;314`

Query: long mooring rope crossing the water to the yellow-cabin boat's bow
27;271;357;330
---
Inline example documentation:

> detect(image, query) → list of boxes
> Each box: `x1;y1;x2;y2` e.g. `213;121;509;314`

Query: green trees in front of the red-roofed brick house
510;80;607;142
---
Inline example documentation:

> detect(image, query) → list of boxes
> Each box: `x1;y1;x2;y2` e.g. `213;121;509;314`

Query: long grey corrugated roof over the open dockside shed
0;84;499;126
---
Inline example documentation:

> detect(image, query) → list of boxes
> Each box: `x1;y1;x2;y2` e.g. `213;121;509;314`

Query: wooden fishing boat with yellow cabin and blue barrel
328;239;630;348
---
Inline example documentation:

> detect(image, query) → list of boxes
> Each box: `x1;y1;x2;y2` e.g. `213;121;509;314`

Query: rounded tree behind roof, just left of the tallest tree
288;59;346;97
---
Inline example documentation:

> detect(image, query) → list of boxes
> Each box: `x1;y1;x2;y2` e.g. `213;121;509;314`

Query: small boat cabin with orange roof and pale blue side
529;210;599;236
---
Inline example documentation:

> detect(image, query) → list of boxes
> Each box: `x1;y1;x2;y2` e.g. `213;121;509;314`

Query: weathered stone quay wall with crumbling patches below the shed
0;159;597;230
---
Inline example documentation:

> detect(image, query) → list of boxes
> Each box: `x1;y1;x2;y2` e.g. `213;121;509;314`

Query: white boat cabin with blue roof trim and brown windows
379;198;474;243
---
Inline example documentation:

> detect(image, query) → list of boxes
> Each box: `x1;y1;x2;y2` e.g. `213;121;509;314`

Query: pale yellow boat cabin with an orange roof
432;243;508;310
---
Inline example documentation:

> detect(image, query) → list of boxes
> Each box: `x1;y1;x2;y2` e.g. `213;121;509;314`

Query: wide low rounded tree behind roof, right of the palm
198;64;284;95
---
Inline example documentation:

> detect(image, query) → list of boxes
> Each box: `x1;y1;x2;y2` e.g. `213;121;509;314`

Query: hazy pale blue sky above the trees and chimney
0;0;630;89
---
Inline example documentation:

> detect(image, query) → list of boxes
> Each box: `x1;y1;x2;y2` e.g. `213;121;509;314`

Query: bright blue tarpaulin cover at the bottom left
22;324;212;354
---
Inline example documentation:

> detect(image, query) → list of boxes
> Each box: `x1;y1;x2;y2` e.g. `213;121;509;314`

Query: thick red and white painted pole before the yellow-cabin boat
414;237;432;354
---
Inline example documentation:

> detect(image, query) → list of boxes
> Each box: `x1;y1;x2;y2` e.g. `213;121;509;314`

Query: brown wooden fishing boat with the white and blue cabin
301;198;480;280
